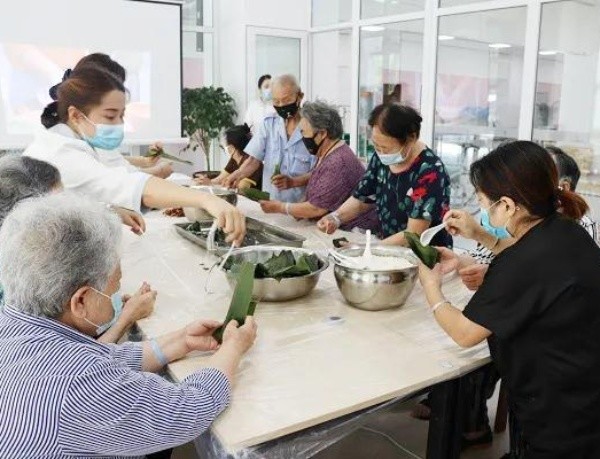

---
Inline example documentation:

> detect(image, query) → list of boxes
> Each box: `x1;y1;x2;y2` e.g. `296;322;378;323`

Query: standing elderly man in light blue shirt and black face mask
224;75;316;202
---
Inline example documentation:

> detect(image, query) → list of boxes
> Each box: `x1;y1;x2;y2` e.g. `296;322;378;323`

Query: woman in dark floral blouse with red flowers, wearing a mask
317;104;452;247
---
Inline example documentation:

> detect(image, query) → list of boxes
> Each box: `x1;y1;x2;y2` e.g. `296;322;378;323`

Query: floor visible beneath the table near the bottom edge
173;386;508;459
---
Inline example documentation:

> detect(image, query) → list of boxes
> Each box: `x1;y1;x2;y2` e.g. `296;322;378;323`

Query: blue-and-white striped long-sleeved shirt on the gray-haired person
0;306;230;459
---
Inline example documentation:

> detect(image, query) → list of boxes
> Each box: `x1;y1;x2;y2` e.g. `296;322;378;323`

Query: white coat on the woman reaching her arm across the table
23;124;151;212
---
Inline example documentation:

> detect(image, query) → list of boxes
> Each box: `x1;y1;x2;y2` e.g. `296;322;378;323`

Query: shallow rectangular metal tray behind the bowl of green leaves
175;217;306;255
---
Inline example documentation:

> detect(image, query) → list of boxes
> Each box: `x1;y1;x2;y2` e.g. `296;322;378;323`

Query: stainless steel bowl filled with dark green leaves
225;246;329;302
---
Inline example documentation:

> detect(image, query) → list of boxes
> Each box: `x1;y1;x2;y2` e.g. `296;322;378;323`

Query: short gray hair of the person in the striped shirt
0;192;121;318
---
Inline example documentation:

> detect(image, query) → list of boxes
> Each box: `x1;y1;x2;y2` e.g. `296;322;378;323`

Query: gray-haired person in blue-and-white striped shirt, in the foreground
0;192;256;459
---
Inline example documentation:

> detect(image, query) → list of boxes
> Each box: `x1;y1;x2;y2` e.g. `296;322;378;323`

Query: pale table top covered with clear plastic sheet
122;198;489;452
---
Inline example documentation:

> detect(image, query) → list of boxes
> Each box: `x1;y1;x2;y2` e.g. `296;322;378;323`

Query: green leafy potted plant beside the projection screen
182;86;237;178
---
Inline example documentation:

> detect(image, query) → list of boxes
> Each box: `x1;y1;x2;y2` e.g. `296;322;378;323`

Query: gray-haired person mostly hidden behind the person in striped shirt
0;155;156;343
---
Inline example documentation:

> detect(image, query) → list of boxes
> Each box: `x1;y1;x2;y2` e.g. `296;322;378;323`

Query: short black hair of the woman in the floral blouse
369;104;423;143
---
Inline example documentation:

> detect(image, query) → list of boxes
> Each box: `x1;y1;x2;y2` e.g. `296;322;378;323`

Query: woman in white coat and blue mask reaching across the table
24;65;246;242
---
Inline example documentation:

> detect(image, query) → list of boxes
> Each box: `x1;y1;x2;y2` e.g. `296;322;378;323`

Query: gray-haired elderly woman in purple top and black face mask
260;101;379;232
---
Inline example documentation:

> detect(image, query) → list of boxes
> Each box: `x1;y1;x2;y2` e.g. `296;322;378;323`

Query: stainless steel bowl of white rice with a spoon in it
333;246;418;311
